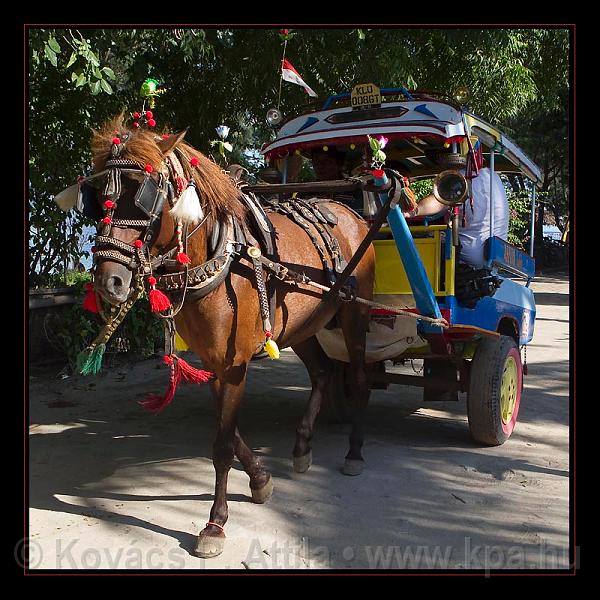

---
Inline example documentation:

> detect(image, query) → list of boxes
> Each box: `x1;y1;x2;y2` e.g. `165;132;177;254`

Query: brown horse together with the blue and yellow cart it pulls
56;84;540;558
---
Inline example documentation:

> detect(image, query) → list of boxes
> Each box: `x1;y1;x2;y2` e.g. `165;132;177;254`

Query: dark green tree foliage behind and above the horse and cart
27;27;569;281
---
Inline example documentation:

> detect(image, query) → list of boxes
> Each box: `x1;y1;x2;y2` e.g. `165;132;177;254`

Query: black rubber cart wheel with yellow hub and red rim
467;335;523;446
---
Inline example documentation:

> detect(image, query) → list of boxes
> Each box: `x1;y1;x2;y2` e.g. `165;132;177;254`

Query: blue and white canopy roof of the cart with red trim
261;88;542;185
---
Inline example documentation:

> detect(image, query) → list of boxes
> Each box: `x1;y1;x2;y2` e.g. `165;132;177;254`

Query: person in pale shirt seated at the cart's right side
404;167;508;267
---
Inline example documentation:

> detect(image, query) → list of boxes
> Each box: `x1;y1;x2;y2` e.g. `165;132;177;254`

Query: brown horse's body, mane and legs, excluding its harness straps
92;116;374;558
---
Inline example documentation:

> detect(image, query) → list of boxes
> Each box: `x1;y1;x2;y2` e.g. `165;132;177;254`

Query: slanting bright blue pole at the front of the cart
375;173;442;324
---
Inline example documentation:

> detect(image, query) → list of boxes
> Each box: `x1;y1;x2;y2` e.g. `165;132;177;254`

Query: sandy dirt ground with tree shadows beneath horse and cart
29;274;569;569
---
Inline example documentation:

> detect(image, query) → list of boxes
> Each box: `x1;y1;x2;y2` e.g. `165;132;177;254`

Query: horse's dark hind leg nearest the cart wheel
340;304;370;475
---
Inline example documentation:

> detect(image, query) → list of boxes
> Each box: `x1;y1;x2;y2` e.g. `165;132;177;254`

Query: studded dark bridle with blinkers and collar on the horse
77;150;244;316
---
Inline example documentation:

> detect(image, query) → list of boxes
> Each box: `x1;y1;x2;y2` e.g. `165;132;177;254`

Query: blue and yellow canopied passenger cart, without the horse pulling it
248;84;541;445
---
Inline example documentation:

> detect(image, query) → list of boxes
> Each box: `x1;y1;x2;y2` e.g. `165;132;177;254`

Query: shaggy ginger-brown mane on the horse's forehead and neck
92;113;246;220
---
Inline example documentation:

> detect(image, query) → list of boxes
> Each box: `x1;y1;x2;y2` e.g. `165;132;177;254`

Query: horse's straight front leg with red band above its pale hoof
195;364;247;558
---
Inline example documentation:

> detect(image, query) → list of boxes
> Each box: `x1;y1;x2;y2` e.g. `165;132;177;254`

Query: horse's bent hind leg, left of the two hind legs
292;336;333;473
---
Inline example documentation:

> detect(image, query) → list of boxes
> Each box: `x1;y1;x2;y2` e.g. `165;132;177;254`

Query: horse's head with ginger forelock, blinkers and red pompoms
80;115;243;305
